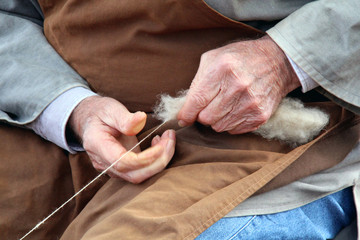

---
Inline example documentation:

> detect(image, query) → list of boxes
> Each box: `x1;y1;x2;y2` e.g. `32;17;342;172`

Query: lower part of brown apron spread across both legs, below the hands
0;109;359;239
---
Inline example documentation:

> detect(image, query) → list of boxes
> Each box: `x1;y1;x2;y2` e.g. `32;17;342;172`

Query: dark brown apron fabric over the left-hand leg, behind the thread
0;124;107;240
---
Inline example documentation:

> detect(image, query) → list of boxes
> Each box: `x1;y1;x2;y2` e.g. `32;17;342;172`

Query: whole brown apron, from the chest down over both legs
0;0;359;240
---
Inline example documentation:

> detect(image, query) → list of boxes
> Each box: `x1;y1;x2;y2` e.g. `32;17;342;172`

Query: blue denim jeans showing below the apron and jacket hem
196;188;356;240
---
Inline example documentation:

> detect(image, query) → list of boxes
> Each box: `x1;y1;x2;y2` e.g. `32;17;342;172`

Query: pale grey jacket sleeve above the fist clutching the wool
267;0;360;114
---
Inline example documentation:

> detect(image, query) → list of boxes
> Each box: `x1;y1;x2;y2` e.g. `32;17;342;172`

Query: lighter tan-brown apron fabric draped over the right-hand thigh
64;112;359;239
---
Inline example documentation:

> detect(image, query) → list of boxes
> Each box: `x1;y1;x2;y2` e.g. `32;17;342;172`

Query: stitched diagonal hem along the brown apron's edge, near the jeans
185;145;312;239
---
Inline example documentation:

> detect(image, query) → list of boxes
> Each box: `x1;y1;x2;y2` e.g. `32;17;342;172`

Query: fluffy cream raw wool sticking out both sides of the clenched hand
154;90;329;146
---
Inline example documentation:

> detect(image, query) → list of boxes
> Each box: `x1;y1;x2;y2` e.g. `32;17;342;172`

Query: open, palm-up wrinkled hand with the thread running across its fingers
69;96;175;183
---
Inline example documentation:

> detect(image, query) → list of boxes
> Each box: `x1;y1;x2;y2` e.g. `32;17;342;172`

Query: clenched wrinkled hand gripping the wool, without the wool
178;36;300;134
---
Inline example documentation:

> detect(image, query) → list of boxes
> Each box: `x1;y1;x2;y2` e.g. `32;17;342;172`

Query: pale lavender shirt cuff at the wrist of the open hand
27;87;96;153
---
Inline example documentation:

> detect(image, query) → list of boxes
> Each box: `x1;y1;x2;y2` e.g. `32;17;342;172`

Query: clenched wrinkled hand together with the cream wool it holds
155;36;329;145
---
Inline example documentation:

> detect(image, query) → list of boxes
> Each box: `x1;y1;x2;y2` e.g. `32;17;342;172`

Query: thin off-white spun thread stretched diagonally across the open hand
19;122;165;240
